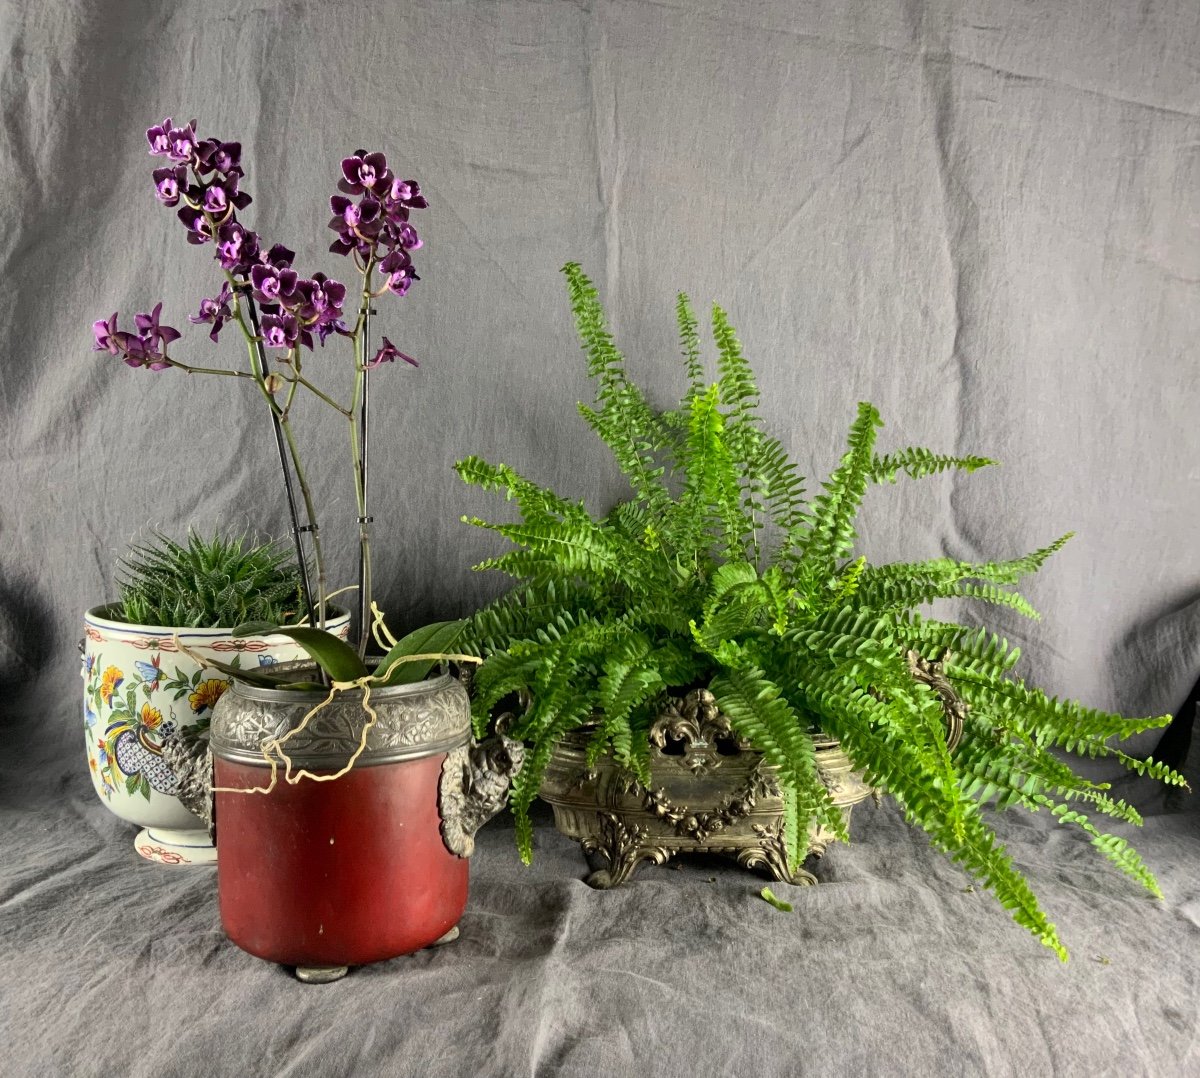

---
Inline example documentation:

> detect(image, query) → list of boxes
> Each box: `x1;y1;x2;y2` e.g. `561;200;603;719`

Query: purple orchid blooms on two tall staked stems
92;118;428;655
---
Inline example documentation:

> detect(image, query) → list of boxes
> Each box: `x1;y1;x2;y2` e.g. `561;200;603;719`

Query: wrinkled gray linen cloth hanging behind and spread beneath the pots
0;0;1200;1076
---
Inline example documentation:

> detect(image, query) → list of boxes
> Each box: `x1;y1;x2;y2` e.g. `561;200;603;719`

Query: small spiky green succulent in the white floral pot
113;529;304;629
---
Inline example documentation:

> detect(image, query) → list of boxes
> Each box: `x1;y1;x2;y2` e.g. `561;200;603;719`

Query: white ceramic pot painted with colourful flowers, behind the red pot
82;606;350;864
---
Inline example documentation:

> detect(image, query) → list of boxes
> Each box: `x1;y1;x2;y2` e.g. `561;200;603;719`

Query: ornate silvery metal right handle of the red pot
438;733;524;857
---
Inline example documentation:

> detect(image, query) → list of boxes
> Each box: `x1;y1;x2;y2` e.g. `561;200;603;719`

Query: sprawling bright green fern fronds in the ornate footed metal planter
457;263;1184;958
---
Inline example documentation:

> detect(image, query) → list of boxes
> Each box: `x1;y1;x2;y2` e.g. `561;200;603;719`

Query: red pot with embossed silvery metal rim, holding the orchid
210;675;521;981
